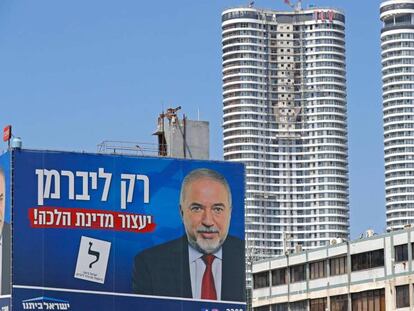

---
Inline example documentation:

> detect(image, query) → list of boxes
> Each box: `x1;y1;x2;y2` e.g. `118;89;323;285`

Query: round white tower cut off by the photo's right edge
380;0;414;229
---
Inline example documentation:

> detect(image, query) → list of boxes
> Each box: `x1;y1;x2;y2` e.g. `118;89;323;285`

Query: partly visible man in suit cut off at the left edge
0;168;11;295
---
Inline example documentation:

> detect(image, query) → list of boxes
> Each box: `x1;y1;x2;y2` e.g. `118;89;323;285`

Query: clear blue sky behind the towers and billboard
0;0;385;238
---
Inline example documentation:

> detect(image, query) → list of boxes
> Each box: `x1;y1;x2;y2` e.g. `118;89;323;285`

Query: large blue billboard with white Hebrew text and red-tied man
12;150;245;311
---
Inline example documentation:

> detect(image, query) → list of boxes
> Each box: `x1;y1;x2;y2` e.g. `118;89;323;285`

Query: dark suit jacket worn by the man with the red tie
132;236;246;301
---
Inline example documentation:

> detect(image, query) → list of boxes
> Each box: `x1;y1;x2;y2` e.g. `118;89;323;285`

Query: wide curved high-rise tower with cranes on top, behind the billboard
222;8;349;261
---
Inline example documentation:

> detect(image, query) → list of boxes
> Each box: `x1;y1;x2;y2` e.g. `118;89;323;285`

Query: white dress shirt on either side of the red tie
188;245;223;300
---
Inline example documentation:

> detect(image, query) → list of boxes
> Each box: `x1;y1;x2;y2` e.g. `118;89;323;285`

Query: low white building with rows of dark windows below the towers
252;228;414;311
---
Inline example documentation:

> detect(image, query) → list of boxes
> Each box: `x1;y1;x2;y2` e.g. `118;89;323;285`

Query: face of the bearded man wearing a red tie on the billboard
181;177;231;254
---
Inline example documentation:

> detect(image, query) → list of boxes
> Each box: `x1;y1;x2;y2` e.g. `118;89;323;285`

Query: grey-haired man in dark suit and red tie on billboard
132;168;245;302
